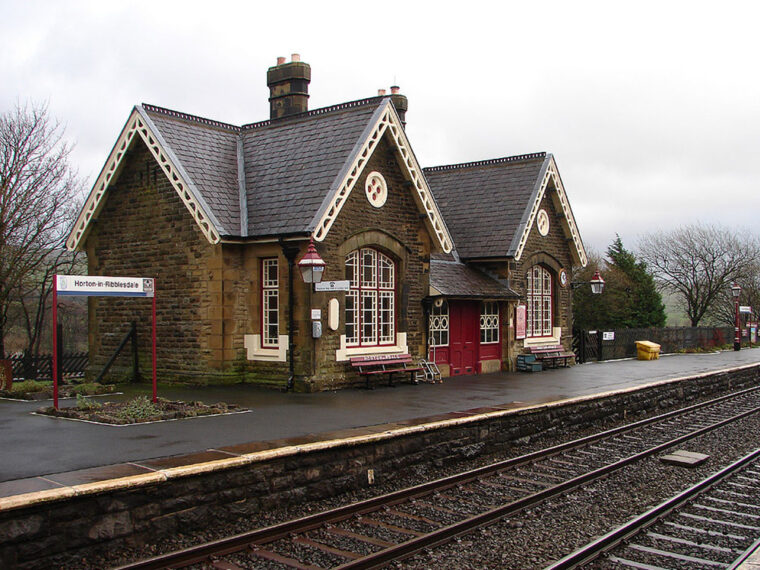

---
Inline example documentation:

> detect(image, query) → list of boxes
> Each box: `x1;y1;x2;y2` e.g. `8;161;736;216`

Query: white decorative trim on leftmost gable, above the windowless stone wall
66;108;220;250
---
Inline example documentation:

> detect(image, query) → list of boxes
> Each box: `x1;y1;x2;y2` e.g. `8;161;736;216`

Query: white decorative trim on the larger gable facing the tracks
314;101;452;253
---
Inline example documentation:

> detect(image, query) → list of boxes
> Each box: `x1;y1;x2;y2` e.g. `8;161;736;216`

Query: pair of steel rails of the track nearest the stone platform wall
115;387;760;570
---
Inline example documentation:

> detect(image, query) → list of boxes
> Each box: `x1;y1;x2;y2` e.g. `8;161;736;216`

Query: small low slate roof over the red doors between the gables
430;255;519;299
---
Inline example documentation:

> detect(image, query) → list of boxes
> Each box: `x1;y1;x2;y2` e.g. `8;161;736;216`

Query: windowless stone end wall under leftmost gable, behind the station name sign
86;142;224;381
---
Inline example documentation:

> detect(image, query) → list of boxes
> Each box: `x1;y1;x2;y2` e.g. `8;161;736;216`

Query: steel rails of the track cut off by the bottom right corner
544;449;760;570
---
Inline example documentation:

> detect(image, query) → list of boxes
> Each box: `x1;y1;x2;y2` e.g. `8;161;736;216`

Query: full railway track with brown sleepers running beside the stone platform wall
120;388;760;570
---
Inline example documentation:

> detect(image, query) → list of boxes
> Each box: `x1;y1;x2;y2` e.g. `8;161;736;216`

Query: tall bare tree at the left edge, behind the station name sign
0;105;82;355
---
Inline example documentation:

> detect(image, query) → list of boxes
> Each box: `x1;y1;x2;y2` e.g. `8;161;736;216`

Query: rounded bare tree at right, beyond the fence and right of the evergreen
639;224;758;326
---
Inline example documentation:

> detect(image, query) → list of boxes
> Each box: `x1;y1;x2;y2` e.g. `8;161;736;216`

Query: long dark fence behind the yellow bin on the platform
573;327;734;362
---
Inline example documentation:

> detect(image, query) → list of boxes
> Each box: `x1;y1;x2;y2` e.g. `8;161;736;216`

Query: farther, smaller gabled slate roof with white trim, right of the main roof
424;152;587;266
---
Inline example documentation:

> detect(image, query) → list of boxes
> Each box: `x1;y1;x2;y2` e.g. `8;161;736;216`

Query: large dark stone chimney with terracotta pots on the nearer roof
267;53;311;119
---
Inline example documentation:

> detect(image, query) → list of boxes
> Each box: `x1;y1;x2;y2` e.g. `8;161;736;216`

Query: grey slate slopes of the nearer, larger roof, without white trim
142;97;389;237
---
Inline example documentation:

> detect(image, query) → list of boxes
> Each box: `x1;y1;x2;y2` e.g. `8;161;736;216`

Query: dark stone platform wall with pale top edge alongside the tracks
0;365;760;568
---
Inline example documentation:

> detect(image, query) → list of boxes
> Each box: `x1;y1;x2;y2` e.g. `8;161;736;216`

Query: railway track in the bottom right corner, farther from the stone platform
546;449;760;570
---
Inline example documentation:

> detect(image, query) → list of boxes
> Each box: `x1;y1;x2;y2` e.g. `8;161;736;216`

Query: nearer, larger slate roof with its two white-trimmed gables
67;97;452;251
